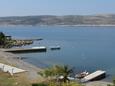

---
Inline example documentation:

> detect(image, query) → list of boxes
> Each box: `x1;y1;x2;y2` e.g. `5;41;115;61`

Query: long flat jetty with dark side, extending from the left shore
0;46;47;53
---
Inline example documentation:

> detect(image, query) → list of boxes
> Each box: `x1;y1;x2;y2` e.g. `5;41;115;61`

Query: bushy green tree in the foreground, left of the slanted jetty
40;65;73;82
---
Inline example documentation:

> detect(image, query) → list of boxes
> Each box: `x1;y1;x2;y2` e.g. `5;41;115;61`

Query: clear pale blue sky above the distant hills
0;0;115;16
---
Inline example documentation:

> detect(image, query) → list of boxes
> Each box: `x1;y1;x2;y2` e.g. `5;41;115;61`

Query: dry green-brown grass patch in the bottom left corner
0;71;31;86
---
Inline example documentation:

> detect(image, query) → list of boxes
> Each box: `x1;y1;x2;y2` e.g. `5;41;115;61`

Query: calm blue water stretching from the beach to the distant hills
0;26;115;80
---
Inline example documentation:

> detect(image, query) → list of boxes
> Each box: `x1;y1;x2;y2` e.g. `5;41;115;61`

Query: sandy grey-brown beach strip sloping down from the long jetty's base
0;51;42;82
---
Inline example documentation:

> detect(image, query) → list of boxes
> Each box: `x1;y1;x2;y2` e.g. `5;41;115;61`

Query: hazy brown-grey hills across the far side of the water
0;14;115;25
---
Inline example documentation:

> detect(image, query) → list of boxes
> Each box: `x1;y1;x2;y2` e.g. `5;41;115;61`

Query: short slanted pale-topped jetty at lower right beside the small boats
81;70;106;82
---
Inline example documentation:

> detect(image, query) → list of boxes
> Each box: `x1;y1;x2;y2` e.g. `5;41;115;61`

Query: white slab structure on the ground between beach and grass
0;63;26;75
